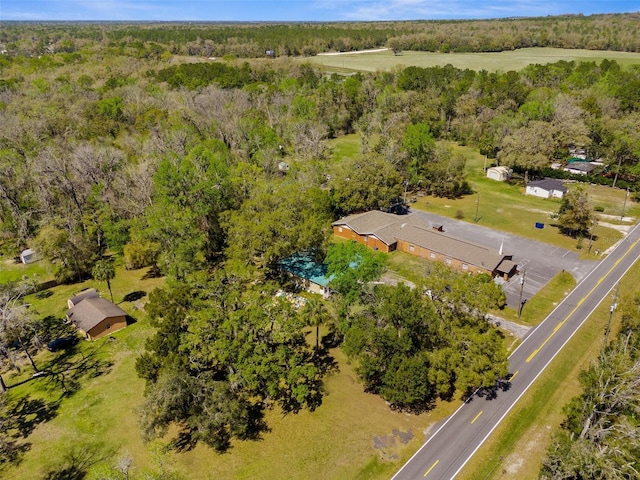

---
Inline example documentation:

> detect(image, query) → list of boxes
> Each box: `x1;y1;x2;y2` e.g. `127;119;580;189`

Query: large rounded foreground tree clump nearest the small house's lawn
136;275;331;451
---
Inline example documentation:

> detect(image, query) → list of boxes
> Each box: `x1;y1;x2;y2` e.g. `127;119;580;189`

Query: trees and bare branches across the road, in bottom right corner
540;294;640;480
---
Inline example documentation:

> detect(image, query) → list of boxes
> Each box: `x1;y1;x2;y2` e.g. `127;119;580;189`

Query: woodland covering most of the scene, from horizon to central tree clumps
0;15;640;476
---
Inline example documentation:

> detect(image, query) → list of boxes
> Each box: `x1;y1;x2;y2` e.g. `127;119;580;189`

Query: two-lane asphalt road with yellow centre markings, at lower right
393;225;640;480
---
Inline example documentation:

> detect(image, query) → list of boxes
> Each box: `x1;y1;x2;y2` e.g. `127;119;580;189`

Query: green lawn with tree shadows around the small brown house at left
0;262;164;480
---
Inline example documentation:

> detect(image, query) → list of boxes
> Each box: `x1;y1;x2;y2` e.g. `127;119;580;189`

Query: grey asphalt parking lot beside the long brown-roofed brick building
411;210;598;309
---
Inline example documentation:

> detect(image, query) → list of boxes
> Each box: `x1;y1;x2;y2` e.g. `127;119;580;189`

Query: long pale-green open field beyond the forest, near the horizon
302;48;640;73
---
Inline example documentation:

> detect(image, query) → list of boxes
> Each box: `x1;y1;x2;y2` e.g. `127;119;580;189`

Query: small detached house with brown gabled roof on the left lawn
67;293;127;340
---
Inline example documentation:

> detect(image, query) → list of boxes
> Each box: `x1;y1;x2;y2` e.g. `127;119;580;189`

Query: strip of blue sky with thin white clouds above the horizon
0;0;640;22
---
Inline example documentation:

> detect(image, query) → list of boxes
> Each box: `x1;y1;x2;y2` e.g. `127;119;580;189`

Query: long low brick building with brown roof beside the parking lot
333;211;517;280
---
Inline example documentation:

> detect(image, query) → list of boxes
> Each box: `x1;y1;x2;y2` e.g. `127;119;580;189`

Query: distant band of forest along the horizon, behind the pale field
0;13;640;58
